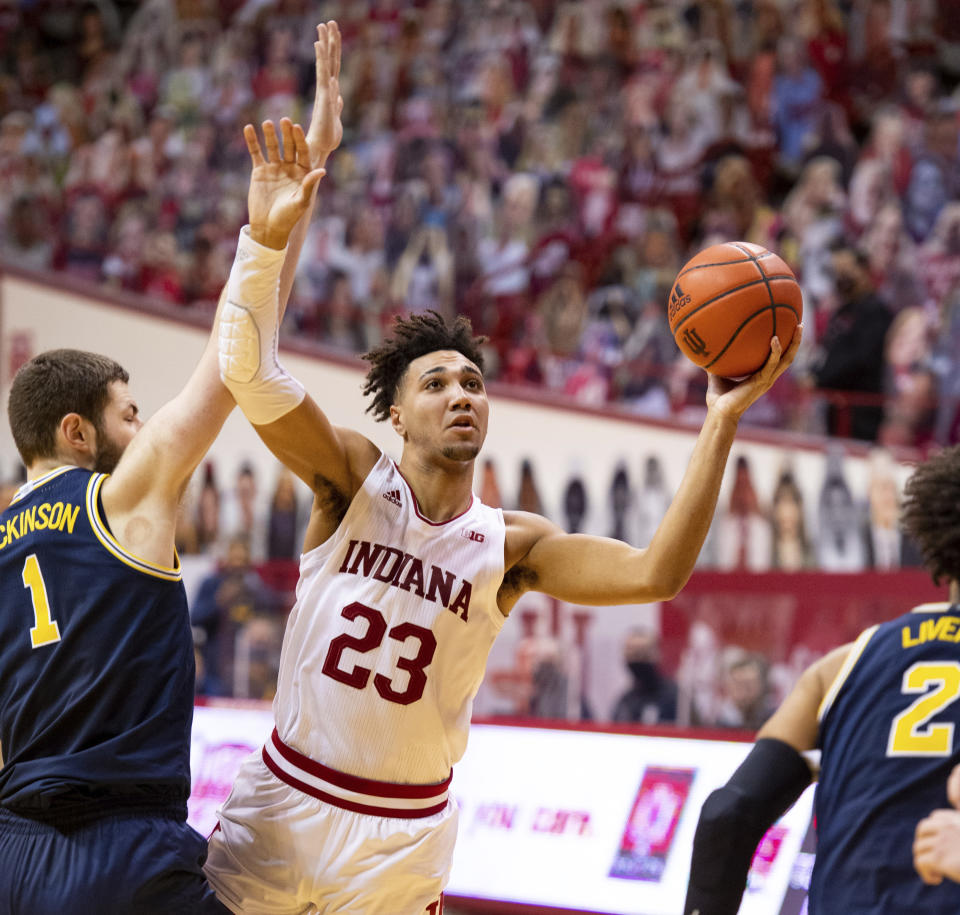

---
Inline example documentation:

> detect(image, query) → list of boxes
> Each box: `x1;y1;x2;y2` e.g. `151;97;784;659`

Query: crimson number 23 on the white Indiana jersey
323;601;437;705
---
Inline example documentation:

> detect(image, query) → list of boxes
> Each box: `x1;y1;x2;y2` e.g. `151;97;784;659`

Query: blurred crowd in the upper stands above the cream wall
0;0;960;444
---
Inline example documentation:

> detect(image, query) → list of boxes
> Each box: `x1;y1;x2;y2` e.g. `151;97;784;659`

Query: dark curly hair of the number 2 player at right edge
900;445;960;584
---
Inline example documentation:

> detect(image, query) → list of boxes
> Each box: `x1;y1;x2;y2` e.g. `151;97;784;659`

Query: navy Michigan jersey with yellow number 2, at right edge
810;604;960;915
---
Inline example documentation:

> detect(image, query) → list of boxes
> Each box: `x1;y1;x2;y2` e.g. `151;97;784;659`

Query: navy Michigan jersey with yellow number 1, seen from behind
0;467;194;816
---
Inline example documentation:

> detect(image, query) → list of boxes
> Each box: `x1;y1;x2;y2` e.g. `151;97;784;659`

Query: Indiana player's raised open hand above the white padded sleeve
243;118;326;249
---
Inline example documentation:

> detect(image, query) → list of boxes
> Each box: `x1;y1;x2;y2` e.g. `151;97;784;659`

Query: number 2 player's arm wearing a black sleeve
683;645;850;915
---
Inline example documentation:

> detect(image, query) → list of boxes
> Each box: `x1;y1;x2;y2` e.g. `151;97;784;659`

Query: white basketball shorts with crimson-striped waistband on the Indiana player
204;732;457;915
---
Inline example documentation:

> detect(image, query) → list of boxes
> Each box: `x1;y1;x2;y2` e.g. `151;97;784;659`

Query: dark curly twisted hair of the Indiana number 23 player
363;311;487;422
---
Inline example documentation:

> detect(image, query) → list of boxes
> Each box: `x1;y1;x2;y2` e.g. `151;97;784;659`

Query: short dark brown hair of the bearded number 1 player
7;349;130;467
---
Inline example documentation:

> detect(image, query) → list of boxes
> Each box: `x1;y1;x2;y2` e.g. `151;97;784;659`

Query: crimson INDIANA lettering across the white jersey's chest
337;540;473;622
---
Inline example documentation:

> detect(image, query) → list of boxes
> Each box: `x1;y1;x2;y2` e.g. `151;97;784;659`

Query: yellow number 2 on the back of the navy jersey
887;661;960;756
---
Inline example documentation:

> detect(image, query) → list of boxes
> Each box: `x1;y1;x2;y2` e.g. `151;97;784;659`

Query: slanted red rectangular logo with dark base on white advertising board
610;767;695;881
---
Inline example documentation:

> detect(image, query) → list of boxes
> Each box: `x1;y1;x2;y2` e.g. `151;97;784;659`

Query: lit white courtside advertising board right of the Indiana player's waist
447;725;813;915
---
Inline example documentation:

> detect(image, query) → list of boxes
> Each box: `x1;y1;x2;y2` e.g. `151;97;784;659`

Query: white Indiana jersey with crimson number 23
273;455;505;784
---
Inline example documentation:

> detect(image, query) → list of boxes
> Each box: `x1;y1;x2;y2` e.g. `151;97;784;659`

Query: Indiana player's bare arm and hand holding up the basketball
501;327;802;610
